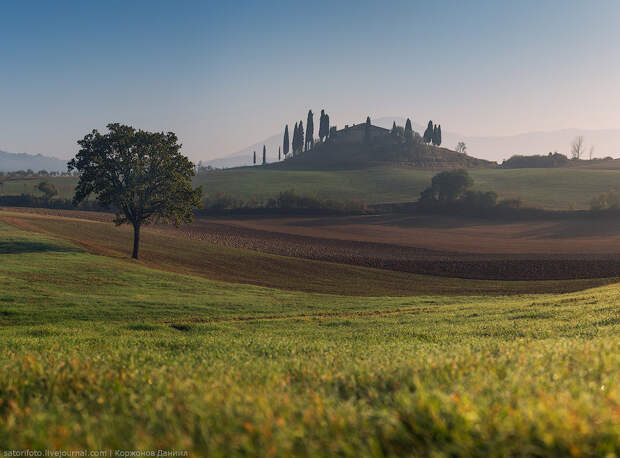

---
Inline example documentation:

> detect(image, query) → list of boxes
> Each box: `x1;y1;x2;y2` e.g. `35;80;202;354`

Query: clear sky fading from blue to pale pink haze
0;0;620;160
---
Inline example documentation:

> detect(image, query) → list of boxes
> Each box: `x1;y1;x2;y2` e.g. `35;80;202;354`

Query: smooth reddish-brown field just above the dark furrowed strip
212;215;620;259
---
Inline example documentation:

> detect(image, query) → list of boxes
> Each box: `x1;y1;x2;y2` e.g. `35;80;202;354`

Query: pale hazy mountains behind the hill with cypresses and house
204;117;620;168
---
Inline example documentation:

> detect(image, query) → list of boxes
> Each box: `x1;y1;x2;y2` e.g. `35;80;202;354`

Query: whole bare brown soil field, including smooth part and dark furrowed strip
6;210;620;281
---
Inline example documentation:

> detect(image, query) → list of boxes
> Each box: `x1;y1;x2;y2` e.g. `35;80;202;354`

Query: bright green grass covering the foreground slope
0;223;620;456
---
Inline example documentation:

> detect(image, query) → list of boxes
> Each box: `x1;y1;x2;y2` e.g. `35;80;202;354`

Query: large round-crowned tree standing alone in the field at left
69;123;202;259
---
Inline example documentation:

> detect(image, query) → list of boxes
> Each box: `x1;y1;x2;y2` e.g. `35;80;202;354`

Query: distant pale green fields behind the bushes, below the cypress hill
6;166;620;209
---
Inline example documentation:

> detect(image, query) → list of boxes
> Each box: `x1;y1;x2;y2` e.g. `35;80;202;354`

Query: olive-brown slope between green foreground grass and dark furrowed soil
6;211;617;296
